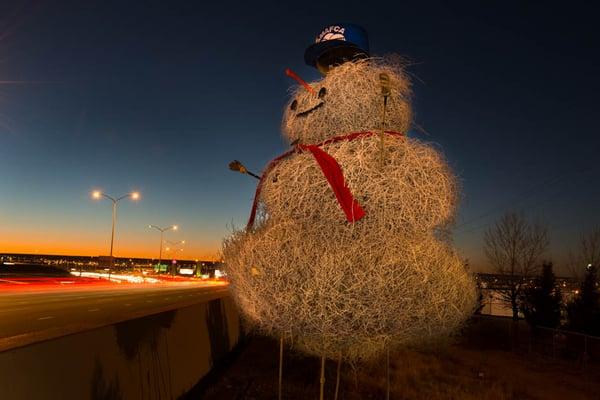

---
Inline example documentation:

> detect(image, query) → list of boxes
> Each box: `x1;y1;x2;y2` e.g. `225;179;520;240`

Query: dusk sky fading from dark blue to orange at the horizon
0;1;600;269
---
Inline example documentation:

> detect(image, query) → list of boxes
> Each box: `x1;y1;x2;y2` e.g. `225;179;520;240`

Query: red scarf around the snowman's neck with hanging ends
246;131;403;230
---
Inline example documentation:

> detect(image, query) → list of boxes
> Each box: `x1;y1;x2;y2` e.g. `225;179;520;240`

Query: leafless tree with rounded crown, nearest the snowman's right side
484;212;549;320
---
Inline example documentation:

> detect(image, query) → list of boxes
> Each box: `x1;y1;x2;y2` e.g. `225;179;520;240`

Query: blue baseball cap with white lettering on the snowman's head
304;24;369;67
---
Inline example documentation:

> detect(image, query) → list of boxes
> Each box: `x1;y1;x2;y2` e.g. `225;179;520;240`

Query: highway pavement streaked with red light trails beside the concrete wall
0;282;228;351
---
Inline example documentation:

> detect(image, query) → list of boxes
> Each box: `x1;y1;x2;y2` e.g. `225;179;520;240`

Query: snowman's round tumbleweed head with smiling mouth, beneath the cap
282;58;412;144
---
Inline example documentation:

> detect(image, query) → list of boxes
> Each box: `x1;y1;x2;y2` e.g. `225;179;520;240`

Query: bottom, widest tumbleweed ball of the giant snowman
224;221;475;360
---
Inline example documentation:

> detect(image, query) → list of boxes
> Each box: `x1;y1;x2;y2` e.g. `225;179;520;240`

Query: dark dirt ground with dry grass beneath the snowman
193;336;600;400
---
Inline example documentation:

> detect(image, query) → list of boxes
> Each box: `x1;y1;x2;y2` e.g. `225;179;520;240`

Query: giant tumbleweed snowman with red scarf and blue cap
223;26;475;361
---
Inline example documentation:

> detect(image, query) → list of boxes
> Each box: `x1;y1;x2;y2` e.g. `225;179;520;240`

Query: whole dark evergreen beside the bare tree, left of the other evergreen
521;263;562;328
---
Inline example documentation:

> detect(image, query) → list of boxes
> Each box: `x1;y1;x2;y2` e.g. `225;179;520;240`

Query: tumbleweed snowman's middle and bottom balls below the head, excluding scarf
223;136;476;361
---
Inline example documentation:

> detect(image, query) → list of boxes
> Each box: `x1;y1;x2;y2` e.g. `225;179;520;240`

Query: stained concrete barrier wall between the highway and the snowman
0;297;240;400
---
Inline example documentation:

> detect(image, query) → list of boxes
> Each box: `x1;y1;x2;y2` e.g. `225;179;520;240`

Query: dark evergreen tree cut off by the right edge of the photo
567;265;600;336
